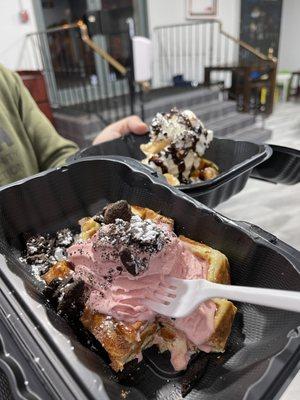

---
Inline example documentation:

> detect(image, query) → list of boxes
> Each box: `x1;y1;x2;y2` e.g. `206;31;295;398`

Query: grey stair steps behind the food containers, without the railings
54;87;272;147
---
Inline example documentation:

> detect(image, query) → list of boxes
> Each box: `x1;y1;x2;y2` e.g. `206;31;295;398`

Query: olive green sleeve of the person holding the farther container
14;74;78;171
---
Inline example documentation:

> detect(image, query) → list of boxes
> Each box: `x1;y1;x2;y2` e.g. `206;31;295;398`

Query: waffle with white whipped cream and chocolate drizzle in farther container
140;108;219;186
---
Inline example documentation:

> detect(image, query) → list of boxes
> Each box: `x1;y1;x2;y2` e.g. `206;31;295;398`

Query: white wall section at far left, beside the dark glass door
0;0;37;70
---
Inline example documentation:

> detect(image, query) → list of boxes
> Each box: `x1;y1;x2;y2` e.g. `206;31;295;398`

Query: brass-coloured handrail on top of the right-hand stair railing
154;18;277;64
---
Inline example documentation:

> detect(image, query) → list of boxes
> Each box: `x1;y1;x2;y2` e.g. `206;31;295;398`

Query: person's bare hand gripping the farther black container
93;115;148;144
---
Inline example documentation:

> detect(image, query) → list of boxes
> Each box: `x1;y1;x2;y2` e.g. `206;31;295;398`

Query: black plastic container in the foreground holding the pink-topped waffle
0;157;300;400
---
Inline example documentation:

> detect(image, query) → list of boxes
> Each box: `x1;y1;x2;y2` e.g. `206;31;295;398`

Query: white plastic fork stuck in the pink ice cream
144;278;300;318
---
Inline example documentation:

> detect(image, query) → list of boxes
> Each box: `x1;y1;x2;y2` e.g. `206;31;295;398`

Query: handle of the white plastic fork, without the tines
206;281;300;312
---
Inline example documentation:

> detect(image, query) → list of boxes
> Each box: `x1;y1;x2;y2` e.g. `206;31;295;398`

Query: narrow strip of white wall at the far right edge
278;0;300;71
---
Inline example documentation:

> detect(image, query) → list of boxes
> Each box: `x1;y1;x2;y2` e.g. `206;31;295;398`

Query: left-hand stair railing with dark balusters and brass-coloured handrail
27;20;135;124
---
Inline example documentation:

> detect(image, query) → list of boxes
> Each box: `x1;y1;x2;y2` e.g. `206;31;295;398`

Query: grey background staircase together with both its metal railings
27;20;277;147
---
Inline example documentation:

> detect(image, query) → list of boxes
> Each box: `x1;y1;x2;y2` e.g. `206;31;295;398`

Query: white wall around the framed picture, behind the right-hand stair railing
147;0;240;87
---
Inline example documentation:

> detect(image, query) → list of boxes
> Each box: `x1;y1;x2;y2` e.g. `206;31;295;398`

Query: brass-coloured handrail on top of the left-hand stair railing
27;20;128;76
